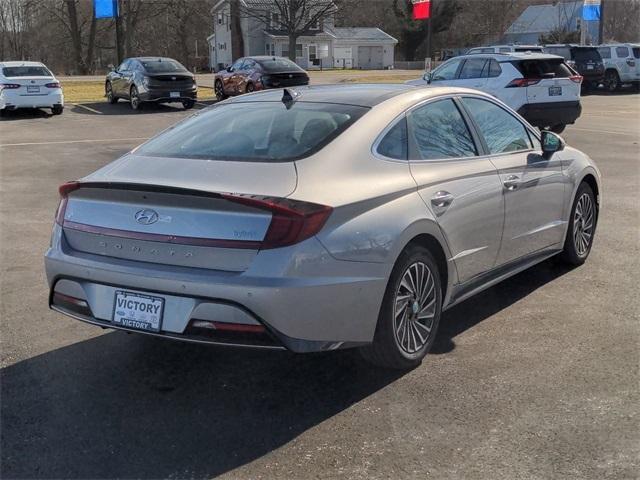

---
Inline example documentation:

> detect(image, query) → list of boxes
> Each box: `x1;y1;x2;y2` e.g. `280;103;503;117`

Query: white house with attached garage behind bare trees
207;0;398;71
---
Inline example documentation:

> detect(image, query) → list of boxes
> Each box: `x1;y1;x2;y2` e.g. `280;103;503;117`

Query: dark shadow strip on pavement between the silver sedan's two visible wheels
431;258;572;354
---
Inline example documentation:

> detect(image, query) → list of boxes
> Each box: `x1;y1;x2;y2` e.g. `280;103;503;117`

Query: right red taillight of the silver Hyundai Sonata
221;194;333;249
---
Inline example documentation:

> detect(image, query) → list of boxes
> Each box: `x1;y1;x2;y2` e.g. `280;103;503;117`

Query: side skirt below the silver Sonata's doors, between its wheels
442;244;562;311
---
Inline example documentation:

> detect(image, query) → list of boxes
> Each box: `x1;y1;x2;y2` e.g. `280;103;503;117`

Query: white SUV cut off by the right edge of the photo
598;43;640;92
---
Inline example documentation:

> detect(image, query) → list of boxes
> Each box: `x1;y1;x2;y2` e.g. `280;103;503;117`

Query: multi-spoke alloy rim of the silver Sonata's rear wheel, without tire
393;262;436;354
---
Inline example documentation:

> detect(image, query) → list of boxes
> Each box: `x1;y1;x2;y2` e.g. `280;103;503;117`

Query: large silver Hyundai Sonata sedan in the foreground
45;85;602;368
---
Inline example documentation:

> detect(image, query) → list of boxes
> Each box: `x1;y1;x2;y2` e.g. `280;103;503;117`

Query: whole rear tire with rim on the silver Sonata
360;245;442;370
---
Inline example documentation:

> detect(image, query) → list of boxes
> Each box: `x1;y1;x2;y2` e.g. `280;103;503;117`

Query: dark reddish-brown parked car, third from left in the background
213;56;309;100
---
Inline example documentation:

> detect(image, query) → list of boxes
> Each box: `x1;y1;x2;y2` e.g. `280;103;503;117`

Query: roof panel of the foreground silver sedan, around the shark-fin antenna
227;83;415;107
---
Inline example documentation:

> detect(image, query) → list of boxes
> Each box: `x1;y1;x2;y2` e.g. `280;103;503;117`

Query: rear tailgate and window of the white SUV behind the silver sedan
514;58;580;103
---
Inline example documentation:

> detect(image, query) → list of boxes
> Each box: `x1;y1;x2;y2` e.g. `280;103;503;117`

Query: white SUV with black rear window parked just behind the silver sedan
407;52;582;133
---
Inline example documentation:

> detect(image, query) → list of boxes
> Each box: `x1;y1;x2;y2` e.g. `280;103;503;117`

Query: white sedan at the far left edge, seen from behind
0;61;64;115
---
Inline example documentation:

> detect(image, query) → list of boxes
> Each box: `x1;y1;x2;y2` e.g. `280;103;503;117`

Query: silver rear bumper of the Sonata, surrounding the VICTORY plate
45;225;389;352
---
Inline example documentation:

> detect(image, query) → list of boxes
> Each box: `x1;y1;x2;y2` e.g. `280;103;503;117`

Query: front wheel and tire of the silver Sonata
560;182;598;266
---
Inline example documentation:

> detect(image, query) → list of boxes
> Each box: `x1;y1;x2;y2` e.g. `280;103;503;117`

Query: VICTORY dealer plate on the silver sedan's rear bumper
111;290;165;332
